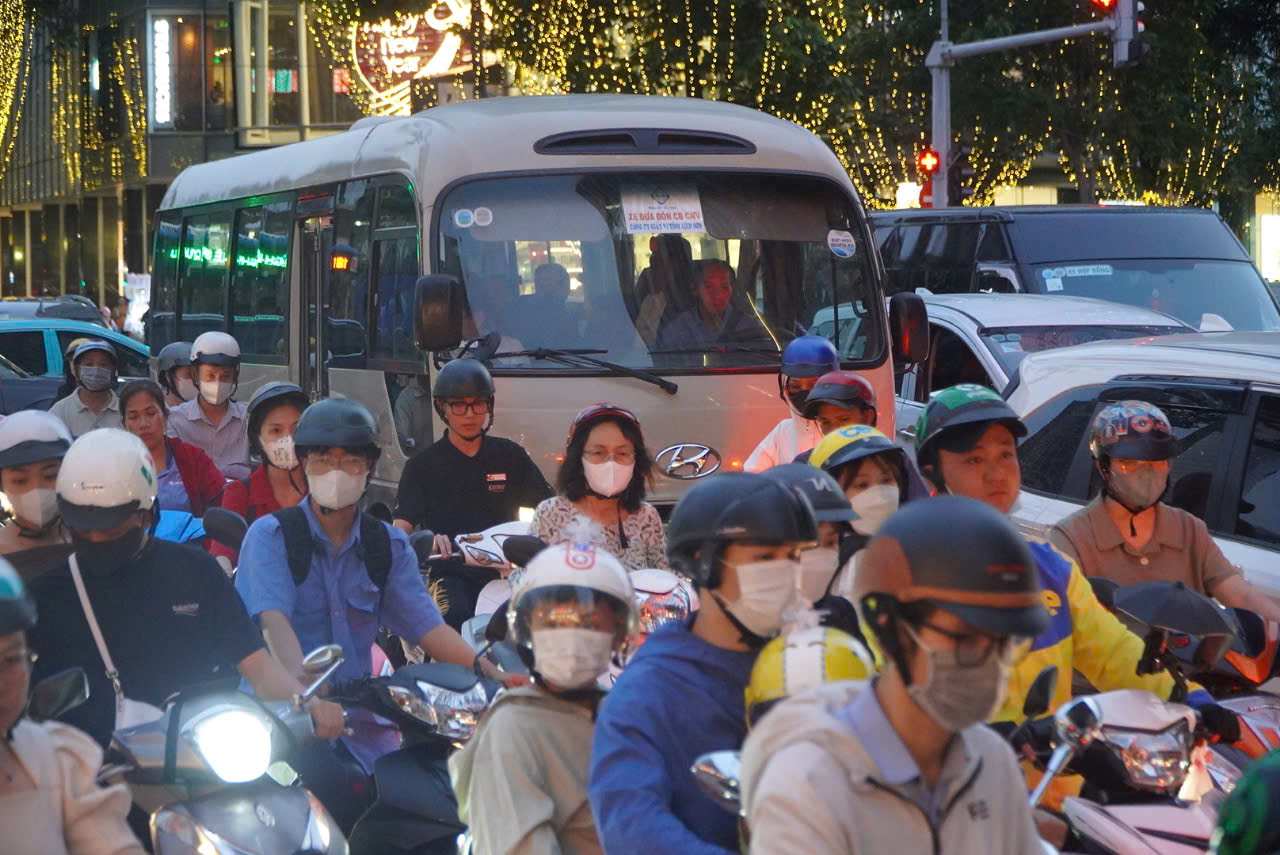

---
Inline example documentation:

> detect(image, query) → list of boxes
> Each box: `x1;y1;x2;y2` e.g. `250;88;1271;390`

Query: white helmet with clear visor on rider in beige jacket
507;543;635;646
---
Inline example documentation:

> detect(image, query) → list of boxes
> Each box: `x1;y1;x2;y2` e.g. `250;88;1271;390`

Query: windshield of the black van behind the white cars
1030;259;1280;332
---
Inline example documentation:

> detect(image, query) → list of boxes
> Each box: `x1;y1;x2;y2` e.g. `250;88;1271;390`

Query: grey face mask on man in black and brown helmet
906;630;1009;733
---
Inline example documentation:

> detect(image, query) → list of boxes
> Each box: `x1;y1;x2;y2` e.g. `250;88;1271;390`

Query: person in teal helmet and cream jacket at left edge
0;555;143;855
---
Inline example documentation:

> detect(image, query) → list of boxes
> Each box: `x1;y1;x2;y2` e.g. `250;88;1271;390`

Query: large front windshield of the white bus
434;173;884;370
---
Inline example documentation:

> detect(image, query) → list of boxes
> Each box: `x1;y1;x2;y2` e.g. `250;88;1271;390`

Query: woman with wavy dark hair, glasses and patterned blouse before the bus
534;403;668;570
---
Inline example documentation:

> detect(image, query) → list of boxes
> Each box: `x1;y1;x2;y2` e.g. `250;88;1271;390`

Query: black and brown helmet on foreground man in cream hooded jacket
854;495;1048;639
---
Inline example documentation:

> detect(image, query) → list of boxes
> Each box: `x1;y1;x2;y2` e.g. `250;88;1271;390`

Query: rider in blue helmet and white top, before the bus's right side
742;335;840;472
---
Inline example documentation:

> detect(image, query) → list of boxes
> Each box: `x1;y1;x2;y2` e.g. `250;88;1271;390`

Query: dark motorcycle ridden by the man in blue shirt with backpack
330;662;499;855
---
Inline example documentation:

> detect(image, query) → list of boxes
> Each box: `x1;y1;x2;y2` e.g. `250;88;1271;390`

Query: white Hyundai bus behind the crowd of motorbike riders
147;95;927;504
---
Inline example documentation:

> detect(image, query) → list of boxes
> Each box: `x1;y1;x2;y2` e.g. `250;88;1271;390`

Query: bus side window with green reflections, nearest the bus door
230;201;292;365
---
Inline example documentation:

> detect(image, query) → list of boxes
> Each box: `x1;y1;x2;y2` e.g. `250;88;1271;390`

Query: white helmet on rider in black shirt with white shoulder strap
56;428;156;531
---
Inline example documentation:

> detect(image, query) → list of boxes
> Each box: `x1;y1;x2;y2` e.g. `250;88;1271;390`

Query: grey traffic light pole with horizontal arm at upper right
924;18;1117;207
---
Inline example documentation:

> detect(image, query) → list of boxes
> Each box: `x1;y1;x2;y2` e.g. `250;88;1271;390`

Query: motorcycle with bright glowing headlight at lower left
99;645;348;855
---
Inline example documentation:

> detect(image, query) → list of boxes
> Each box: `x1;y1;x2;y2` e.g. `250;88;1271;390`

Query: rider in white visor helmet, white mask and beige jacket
449;543;635;855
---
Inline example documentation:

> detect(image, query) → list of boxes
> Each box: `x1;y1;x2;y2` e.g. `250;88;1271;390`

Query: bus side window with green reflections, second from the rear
178;212;232;342
